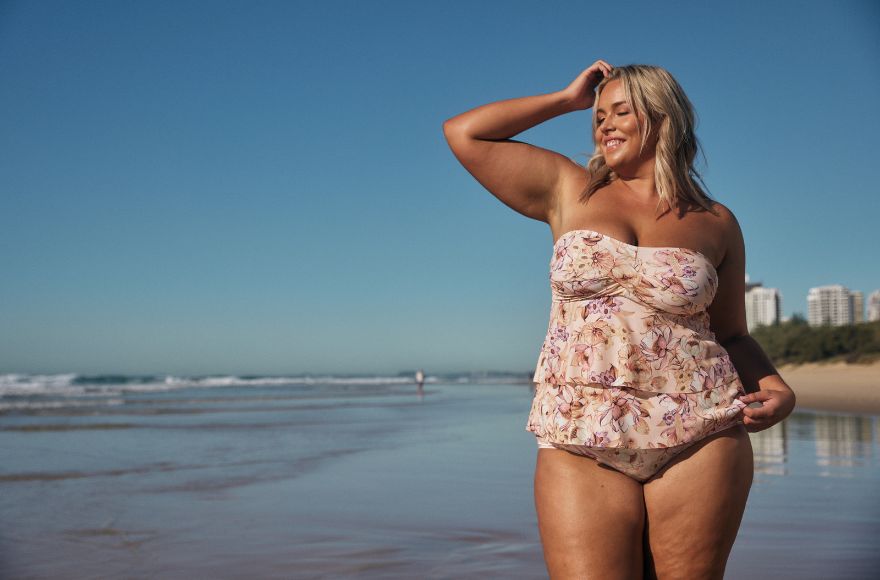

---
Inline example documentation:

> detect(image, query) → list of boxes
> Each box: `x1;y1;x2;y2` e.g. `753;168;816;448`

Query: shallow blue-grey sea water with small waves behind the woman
0;375;880;579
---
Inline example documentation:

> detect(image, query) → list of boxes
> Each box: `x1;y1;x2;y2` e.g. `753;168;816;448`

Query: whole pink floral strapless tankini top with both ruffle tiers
526;230;746;449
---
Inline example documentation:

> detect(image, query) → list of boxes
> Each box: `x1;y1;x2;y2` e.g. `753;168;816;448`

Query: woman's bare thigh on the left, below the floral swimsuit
535;449;645;580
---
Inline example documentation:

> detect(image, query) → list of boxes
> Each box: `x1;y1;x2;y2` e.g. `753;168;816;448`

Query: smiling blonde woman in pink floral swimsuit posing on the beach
443;60;795;580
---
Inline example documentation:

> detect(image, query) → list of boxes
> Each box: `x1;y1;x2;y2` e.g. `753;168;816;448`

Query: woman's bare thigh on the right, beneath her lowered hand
644;425;754;580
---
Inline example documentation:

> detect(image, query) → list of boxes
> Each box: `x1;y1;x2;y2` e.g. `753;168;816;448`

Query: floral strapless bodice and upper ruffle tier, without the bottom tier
533;230;739;393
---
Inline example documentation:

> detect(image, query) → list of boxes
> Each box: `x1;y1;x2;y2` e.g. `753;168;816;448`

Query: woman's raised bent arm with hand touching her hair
443;61;611;223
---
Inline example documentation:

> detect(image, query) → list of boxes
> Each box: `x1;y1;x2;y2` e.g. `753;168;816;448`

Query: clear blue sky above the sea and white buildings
0;0;880;374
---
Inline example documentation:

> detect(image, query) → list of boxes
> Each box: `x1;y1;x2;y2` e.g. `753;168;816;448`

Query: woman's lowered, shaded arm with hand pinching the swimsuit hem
709;204;796;432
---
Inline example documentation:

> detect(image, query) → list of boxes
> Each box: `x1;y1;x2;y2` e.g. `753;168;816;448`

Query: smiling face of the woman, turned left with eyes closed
593;79;656;176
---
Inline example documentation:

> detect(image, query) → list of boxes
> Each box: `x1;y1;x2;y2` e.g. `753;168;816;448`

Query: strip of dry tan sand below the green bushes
777;362;880;415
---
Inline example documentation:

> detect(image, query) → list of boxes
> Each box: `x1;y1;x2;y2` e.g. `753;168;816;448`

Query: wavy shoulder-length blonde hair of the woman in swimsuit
580;64;717;215
